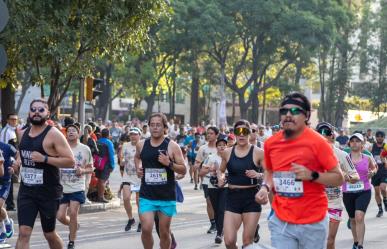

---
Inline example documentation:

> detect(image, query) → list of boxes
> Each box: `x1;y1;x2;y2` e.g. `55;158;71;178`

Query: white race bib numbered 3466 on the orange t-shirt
273;171;304;198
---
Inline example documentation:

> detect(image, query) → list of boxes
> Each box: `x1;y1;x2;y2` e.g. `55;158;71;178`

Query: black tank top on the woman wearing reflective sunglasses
227;145;259;186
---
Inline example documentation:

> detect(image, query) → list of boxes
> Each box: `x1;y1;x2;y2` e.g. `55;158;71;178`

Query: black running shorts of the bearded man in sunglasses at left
17;192;59;233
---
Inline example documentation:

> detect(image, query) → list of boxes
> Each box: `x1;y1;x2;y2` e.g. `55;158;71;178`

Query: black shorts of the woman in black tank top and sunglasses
225;188;262;214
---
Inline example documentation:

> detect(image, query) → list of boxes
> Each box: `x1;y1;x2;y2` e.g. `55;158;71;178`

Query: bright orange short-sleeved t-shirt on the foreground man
264;127;338;224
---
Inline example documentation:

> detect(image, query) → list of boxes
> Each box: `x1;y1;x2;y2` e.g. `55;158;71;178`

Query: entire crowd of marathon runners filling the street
0;93;387;249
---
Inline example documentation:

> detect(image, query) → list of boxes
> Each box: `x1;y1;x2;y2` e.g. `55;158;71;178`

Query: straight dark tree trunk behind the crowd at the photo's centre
190;55;200;126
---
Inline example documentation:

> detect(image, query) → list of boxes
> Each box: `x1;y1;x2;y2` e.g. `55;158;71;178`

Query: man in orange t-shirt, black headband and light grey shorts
255;93;344;249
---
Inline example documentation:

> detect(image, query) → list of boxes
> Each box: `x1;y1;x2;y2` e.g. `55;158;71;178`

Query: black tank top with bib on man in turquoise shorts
140;138;176;201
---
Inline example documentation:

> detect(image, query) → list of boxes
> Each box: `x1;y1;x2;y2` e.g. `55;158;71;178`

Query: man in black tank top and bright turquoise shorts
134;113;187;249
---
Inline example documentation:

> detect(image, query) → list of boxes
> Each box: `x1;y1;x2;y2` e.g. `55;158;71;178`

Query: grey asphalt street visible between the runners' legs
3;170;387;249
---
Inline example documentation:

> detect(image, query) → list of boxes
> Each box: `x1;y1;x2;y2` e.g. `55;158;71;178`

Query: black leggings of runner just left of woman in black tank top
208;188;227;235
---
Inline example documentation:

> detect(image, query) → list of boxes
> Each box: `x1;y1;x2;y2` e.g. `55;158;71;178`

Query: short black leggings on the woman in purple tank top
343;189;371;218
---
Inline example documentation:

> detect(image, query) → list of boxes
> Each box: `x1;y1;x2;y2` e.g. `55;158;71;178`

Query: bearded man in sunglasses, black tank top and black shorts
14;99;75;249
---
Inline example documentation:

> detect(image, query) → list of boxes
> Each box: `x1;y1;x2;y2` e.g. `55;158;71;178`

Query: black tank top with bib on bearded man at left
19;126;63;200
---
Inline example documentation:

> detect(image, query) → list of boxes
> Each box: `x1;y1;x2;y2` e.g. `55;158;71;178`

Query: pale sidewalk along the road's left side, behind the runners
7;183;121;221
